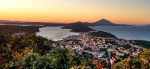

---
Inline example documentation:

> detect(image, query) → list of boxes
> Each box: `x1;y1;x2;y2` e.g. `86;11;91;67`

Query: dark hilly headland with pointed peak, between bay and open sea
63;19;132;32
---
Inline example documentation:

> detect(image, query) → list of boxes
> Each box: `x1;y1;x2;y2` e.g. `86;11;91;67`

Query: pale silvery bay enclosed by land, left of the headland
36;26;79;41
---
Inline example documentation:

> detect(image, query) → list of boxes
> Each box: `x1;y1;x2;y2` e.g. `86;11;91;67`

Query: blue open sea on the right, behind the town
91;26;150;41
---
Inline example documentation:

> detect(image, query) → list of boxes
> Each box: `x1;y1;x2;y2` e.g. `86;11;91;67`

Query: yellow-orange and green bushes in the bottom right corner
114;50;150;69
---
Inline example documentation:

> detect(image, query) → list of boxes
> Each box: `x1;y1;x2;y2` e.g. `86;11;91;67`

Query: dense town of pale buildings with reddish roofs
58;33;142;67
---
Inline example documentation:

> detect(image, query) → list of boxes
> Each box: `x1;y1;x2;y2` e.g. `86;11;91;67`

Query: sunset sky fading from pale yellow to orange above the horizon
0;0;150;24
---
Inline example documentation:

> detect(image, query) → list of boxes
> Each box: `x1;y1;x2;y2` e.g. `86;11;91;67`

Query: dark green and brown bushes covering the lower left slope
0;34;94;69
